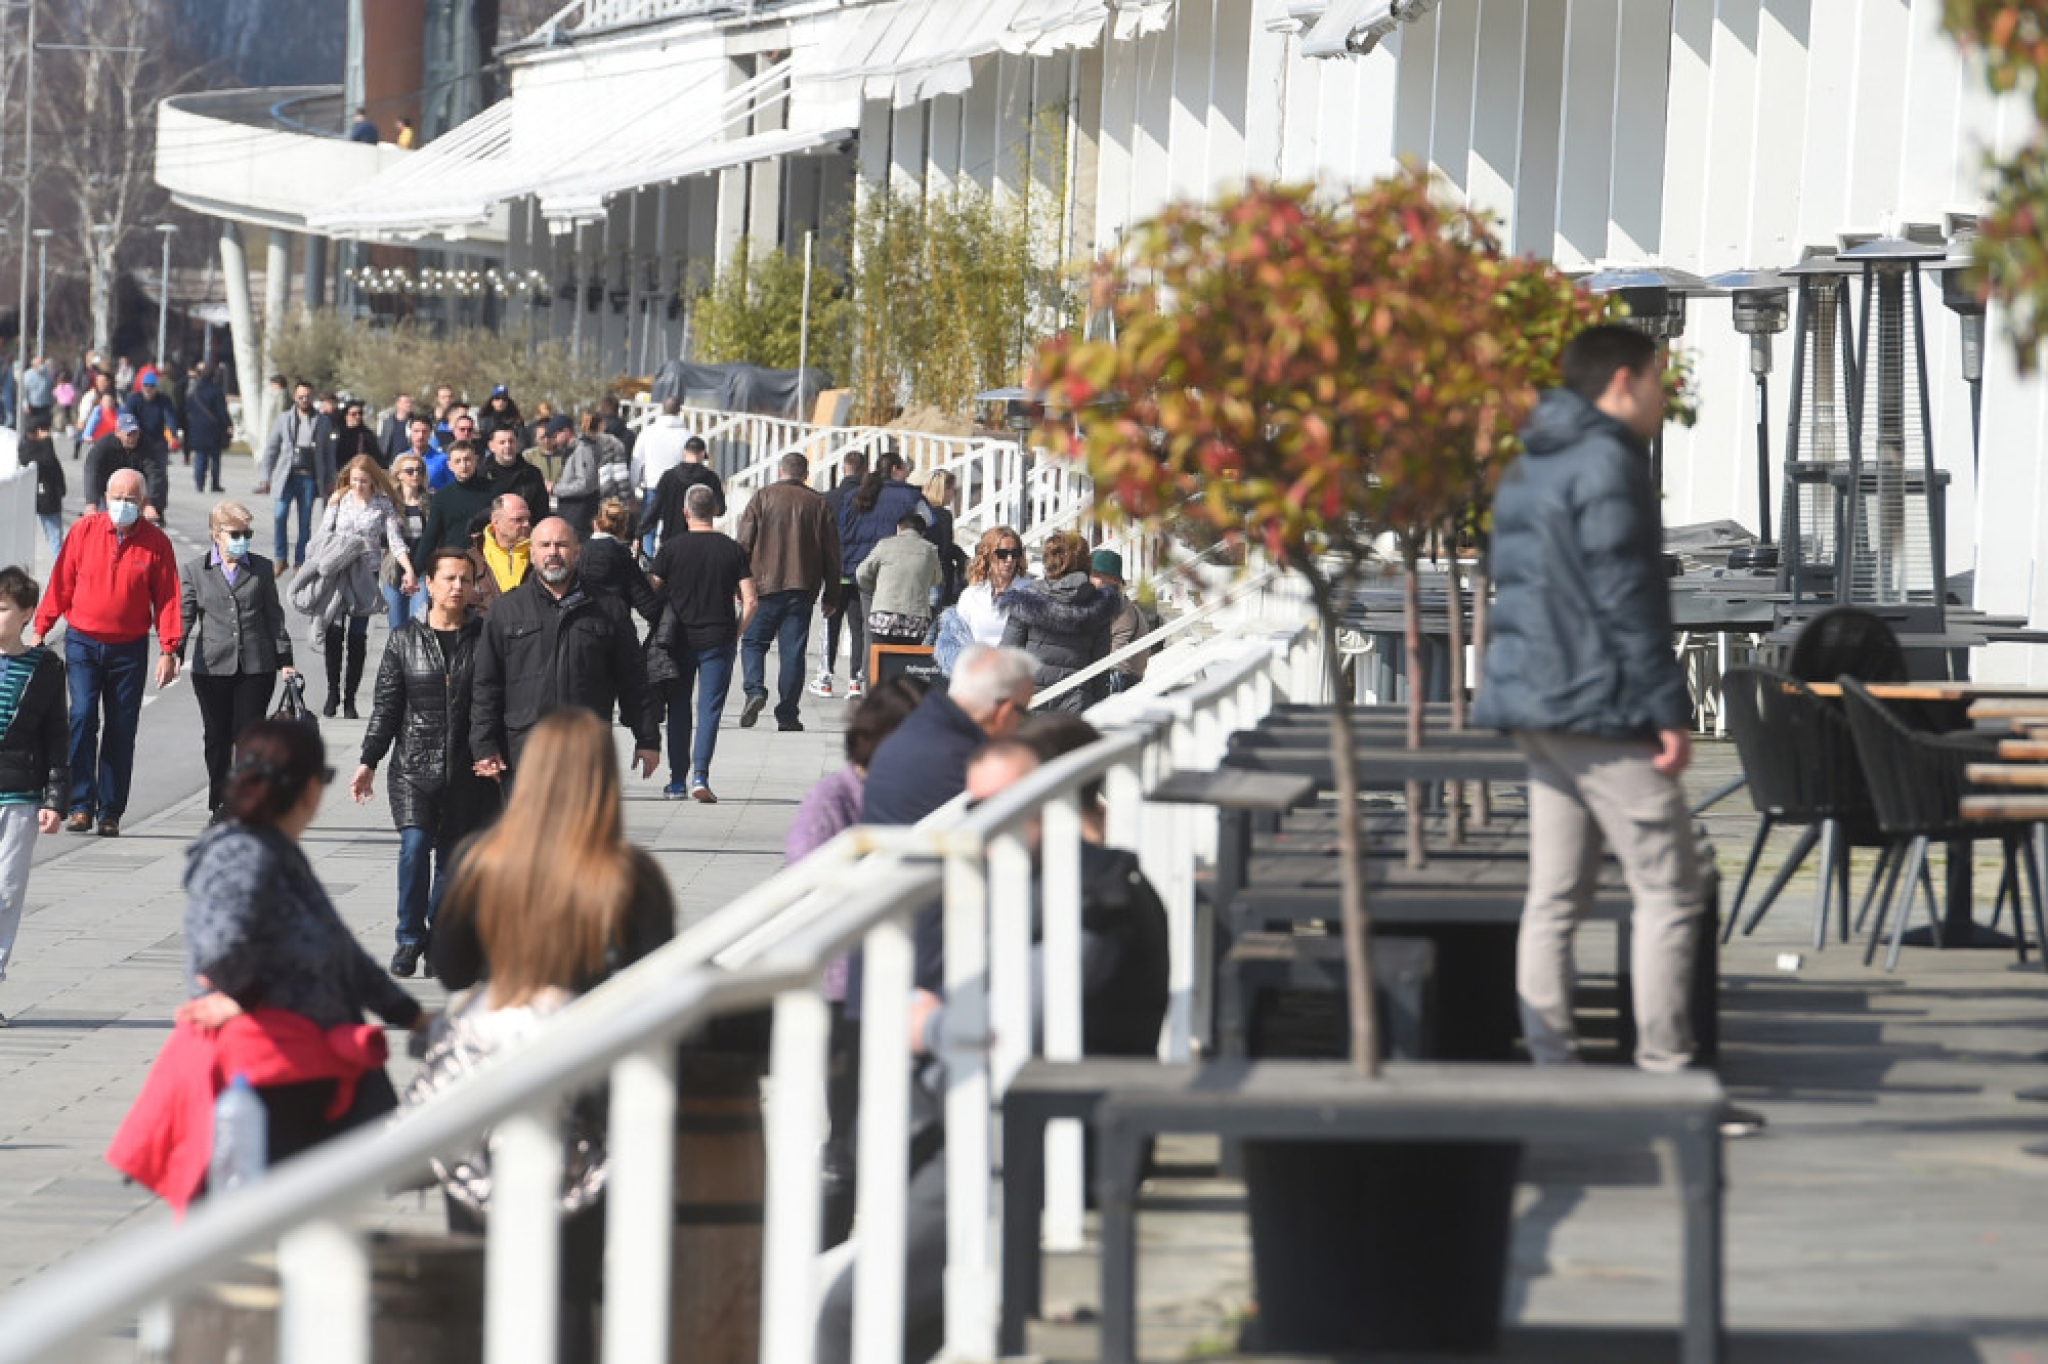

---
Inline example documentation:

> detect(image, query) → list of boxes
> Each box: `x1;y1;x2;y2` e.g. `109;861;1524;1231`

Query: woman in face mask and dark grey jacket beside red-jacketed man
178;502;293;815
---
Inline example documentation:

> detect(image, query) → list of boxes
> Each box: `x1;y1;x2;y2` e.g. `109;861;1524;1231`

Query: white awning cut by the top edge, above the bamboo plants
795;0;1174;109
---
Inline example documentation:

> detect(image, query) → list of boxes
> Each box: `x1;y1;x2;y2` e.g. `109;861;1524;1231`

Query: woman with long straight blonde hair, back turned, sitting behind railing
408;709;676;1360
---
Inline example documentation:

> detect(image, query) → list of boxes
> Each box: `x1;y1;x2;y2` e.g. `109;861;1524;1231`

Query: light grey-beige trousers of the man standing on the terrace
1516;731;1706;1071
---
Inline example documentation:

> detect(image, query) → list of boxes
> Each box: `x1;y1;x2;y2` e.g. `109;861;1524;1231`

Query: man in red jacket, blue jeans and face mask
35;469;184;838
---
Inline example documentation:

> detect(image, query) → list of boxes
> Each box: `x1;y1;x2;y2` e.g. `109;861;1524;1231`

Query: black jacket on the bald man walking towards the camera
469;576;662;764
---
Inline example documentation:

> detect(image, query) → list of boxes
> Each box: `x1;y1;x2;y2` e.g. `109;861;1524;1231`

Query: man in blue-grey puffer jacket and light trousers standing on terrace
1473;326;1706;1071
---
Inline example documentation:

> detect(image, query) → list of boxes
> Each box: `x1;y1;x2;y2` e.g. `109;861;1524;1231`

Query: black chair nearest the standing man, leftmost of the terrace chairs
1720;666;1903;948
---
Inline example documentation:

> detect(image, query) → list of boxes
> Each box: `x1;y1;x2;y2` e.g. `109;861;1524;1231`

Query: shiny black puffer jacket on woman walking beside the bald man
362;621;496;829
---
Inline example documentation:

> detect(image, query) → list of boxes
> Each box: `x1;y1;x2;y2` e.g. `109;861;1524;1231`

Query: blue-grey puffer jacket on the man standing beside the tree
1473;389;1692;739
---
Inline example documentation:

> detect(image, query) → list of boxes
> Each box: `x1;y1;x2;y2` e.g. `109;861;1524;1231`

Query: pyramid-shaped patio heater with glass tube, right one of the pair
1835;238;1948;633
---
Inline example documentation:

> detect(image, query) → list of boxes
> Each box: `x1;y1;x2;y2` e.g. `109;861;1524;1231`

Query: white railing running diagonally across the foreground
0;602;1323;1364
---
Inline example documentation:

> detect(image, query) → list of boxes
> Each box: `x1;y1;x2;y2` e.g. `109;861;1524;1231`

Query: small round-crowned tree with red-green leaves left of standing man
1038;170;1604;1075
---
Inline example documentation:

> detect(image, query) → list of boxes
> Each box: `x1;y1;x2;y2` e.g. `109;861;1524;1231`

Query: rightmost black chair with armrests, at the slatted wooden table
1841;676;2048;971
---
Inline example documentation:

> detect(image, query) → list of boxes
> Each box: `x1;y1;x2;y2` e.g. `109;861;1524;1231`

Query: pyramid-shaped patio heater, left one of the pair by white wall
1778;254;1858;608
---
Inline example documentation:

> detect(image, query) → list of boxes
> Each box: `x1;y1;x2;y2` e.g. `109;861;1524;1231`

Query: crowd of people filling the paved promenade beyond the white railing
0;369;1165;1358
